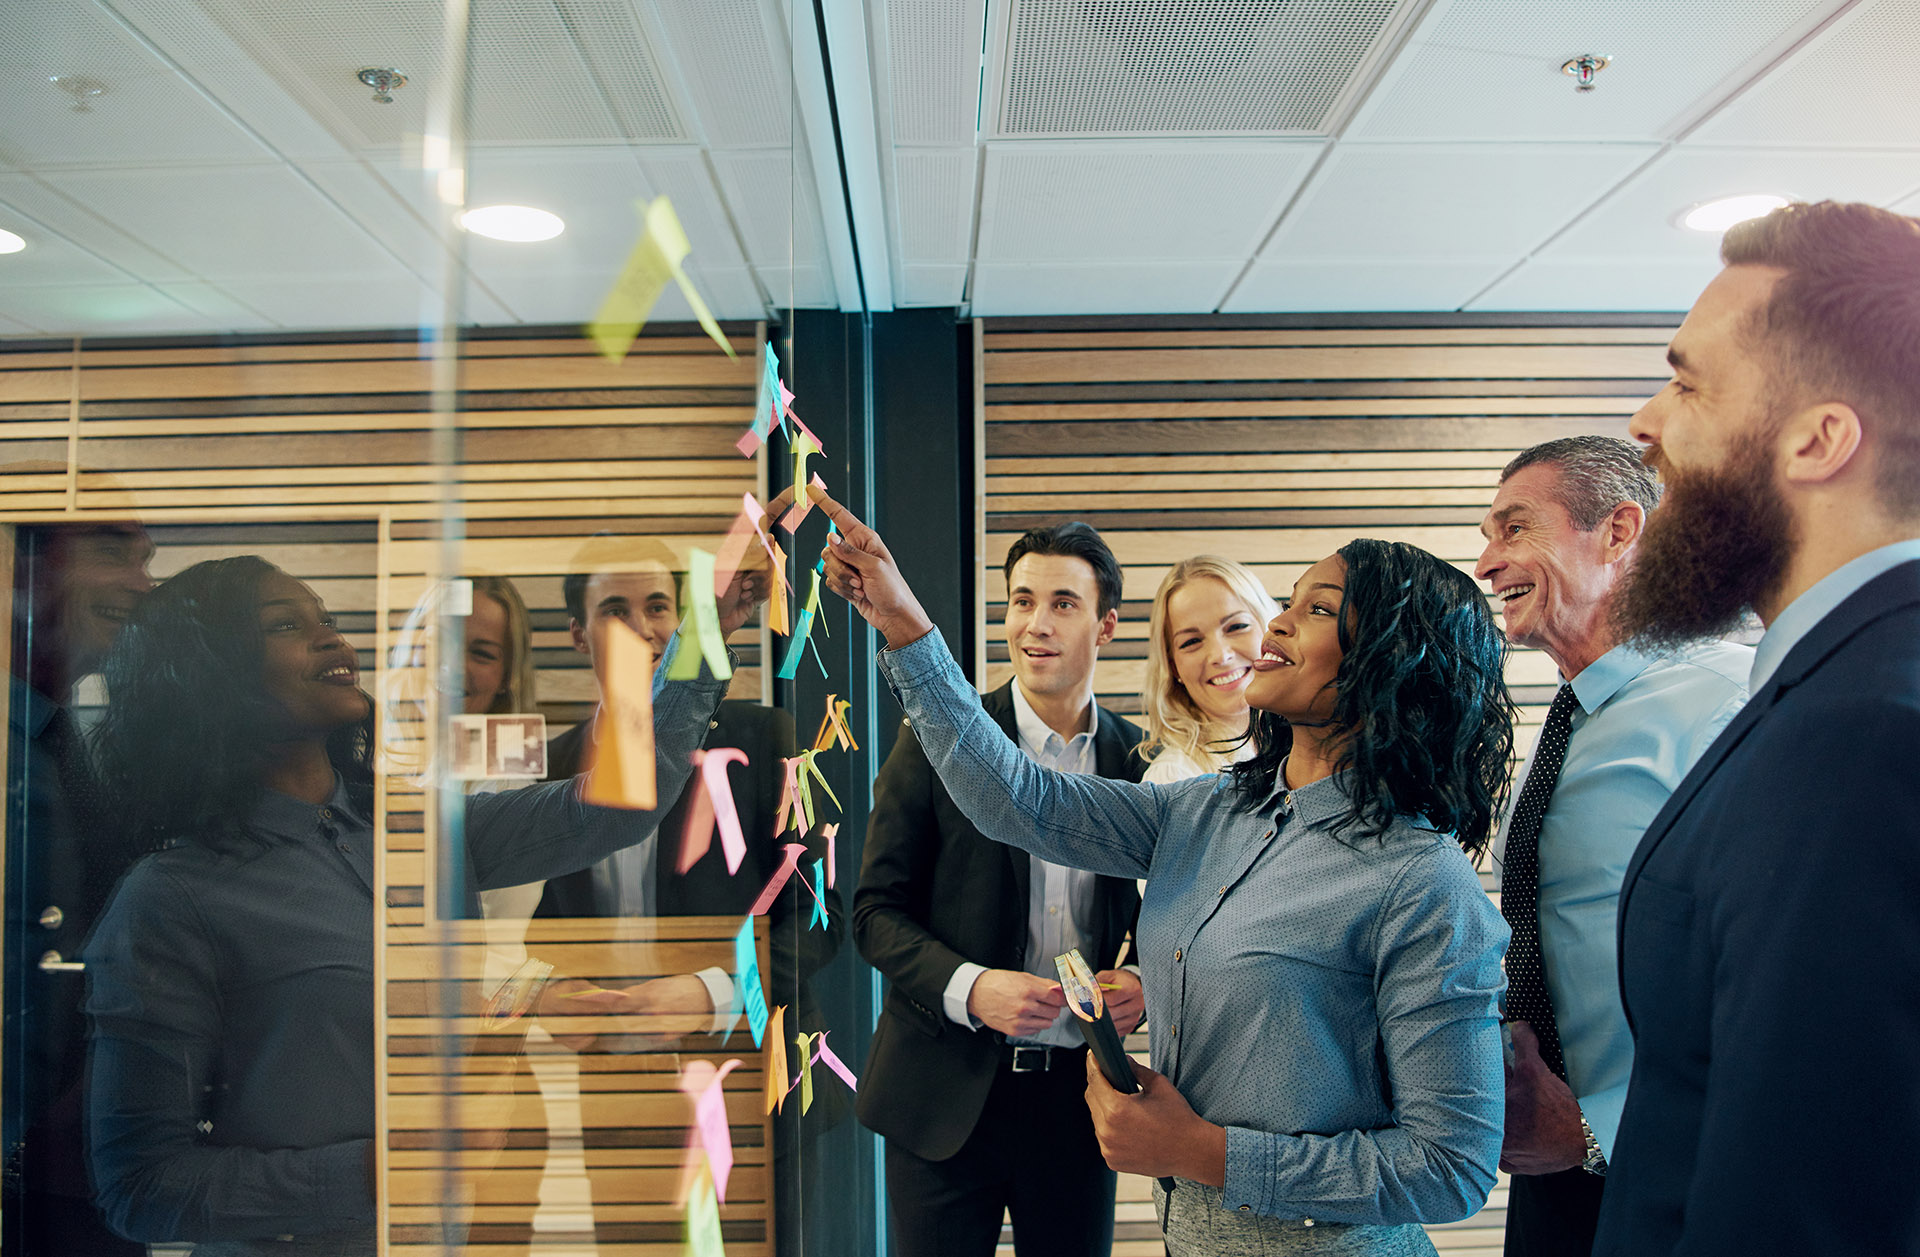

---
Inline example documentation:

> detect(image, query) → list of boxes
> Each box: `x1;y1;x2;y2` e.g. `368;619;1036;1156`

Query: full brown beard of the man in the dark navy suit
1613;439;1795;651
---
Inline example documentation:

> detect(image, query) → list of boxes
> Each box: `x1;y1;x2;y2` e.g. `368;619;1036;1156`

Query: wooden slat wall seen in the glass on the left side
0;326;781;1253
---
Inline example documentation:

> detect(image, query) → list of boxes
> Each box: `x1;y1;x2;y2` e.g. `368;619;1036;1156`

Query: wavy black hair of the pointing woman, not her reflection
1233;537;1513;856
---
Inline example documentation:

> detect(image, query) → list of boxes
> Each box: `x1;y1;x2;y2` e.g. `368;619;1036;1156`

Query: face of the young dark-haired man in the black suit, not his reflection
1006;555;1119;697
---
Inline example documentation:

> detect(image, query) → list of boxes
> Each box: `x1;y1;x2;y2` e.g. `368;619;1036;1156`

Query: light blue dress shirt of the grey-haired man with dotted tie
1494;641;1753;1155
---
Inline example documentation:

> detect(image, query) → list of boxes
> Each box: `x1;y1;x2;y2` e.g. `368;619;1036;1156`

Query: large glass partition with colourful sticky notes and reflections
0;0;876;1257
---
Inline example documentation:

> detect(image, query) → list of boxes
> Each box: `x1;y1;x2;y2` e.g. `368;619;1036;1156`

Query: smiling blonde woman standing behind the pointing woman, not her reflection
1140;555;1279;785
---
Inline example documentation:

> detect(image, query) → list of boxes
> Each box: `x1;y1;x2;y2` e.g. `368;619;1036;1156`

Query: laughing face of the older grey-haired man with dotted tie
1473;462;1630;677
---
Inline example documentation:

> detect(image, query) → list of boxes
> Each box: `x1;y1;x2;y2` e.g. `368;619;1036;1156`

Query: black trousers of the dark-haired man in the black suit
887;1048;1114;1257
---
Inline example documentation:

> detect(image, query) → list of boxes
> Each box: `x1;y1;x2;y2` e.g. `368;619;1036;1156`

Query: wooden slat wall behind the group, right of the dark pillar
975;317;1678;1257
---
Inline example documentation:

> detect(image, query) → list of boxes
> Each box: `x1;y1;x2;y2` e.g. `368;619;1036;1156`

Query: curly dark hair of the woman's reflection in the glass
94;555;372;852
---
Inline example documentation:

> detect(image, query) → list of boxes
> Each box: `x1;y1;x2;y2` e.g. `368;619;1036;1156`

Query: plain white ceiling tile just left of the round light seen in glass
48;165;416;280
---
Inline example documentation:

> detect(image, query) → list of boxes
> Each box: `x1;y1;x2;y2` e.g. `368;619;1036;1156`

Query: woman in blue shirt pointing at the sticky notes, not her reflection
822;487;1513;1257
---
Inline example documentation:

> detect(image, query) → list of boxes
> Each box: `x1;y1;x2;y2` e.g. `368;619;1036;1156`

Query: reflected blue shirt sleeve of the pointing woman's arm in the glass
467;633;726;890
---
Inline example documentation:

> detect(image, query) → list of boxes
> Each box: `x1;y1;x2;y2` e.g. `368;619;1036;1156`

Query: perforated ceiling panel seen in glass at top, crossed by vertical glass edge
200;0;685;150
